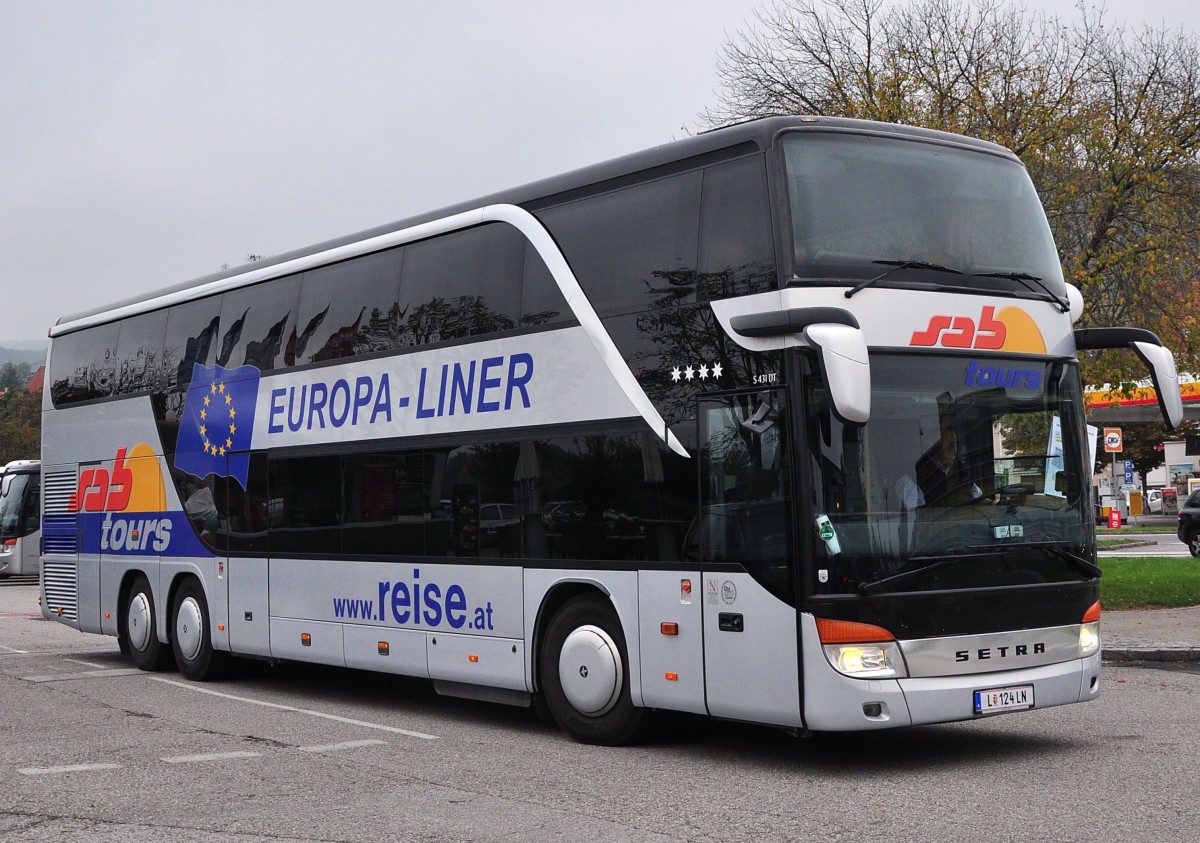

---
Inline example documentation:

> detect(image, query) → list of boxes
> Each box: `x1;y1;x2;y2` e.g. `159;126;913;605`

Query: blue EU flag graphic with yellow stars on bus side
175;364;260;489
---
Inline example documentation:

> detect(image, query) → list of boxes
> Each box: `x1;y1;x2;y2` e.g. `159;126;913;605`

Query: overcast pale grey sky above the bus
0;0;1200;345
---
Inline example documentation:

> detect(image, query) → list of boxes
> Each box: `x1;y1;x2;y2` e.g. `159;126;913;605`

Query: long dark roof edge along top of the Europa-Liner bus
50;116;1016;336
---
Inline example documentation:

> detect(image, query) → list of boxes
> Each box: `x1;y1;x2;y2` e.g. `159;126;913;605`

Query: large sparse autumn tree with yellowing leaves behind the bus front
702;0;1200;385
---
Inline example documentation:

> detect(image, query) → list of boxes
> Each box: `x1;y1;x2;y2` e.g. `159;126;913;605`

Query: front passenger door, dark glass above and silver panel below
688;390;803;727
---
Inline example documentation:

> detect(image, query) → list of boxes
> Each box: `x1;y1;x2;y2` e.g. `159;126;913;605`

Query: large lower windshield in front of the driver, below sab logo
805;354;1098;594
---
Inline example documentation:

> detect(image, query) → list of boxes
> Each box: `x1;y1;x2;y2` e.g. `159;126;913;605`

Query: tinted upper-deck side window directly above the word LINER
400;225;523;346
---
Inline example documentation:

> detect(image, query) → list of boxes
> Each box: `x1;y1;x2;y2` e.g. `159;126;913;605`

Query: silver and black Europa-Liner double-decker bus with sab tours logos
42;118;1182;743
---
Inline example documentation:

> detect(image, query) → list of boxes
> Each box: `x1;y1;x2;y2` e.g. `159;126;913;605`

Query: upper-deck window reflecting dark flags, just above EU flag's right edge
216;276;300;371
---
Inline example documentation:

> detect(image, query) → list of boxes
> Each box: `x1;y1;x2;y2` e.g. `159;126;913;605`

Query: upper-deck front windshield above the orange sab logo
782;132;1066;300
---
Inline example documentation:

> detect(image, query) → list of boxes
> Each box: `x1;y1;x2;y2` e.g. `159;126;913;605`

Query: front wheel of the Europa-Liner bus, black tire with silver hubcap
540;594;646;746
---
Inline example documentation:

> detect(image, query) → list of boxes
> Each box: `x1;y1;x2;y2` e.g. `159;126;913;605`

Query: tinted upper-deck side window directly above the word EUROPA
295;249;403;366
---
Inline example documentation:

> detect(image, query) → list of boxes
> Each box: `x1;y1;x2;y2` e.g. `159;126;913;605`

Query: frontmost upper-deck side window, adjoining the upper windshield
697;156;775;301
